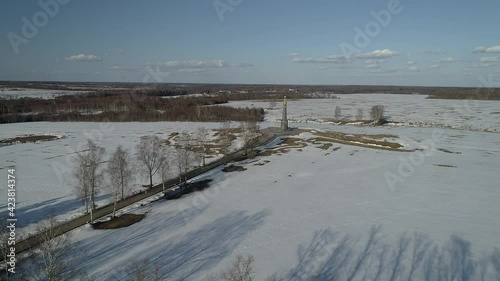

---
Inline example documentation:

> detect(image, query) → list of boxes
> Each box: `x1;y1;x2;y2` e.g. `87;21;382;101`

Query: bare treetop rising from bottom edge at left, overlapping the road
27;214;85;281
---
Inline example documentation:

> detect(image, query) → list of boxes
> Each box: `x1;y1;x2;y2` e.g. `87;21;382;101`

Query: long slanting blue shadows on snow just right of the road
70;207;270;280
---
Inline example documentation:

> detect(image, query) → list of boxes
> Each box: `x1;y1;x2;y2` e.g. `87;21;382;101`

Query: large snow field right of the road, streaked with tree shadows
51;125;500;280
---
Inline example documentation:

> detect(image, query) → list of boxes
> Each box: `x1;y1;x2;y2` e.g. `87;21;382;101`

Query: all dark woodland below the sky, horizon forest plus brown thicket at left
0;82;500;123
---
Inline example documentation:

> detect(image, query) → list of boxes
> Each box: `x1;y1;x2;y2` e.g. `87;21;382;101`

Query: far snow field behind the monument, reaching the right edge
230;94;500;132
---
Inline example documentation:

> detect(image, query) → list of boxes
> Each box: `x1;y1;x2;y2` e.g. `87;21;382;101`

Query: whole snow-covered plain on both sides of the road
0;95;500;280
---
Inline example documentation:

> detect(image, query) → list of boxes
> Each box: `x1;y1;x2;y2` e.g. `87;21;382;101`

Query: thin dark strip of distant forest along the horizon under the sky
0;82;500;100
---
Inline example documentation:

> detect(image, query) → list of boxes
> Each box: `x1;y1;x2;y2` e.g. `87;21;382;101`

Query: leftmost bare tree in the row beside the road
73;139;105;213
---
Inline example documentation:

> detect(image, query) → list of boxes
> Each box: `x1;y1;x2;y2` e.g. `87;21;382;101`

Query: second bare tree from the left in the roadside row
108;145;132;217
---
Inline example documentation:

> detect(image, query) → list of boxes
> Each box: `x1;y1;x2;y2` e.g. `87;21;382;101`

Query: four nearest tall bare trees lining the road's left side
74;136;192;217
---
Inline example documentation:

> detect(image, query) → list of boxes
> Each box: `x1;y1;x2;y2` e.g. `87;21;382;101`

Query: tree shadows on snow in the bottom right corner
286;227;500;281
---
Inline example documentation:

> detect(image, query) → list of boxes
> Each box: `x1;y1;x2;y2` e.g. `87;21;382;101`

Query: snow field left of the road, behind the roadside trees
0;122;238;233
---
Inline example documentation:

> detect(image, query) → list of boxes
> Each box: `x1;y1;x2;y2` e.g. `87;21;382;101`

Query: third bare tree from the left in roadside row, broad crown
137;136;166;188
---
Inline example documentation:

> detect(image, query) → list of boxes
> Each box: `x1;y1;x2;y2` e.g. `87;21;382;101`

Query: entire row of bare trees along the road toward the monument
73;121;259;217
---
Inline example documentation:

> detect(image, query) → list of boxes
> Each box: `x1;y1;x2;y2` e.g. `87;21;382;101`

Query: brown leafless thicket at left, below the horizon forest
0;91;264;123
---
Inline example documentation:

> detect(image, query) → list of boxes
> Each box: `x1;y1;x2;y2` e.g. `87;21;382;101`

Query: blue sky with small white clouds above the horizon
0;0;500;87
